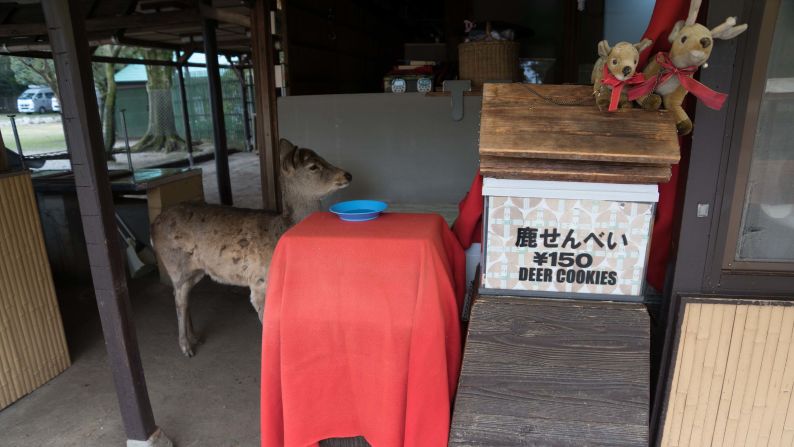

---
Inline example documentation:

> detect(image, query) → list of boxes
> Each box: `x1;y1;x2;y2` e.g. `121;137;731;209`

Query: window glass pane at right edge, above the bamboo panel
736;0;794;262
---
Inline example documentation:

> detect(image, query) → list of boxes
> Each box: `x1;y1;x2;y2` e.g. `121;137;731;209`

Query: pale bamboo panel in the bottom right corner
661;300;794;447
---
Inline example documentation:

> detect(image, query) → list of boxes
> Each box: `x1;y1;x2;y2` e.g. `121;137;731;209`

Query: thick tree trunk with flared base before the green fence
132;50;186;152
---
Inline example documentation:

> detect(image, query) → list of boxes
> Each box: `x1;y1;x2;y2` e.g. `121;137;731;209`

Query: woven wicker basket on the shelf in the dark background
458;40;519;90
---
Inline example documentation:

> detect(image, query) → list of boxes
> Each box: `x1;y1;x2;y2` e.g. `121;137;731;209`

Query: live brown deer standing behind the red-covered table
151;139;353;357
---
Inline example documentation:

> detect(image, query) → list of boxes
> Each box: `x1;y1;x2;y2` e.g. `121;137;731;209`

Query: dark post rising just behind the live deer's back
201;6;232;205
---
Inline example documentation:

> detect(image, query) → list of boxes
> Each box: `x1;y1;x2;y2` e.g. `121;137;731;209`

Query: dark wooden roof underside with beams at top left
0;0;253;55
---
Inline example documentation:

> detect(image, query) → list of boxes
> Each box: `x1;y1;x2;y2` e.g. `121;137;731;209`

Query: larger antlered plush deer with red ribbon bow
629;0;747;135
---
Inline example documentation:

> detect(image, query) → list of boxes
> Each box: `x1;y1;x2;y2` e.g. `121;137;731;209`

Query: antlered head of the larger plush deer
668;0;747;68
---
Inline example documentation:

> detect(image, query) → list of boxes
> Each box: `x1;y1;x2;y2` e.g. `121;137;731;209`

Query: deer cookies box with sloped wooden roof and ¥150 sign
479;84;679;301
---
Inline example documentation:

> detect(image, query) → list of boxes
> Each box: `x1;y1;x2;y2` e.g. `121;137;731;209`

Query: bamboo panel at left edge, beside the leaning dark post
0;172;69;409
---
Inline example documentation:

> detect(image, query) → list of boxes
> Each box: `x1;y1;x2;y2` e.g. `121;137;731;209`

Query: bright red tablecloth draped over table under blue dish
261;213;465;447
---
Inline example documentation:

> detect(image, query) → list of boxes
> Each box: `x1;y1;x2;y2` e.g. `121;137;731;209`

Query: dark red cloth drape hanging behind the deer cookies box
453;0;692;290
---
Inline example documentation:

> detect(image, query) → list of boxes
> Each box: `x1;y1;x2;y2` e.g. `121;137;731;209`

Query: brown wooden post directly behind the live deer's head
251;0;281;211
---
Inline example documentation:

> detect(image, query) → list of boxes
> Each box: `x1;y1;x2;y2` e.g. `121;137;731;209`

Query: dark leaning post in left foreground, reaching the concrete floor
41;0;170;445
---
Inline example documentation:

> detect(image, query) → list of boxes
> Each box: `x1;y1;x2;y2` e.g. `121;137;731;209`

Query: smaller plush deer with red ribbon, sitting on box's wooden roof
590;39;653;112
